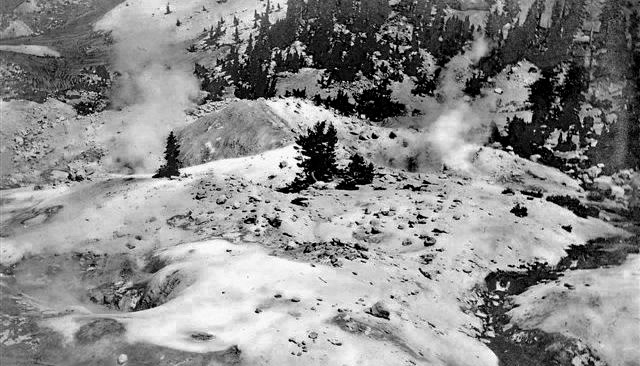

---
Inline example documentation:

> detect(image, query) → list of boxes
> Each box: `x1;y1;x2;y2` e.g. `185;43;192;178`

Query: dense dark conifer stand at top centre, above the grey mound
214;0;477;99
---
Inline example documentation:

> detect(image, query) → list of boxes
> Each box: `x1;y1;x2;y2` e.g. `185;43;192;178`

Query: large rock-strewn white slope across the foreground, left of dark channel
1;142;621;365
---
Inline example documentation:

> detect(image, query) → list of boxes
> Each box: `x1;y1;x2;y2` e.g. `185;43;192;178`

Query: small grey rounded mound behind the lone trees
177;100;292;166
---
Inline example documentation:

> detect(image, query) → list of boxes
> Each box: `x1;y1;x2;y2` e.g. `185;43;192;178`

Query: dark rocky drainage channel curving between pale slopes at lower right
473;236;640;366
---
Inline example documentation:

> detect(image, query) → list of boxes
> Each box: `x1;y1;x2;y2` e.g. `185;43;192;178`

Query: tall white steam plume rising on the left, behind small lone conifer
97;0;199;173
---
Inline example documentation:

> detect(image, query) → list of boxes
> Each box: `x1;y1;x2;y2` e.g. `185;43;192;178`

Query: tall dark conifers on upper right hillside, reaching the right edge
484;0;640;172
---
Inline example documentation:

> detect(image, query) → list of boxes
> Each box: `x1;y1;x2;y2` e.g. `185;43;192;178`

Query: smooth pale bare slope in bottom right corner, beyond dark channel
510;254;640;366
